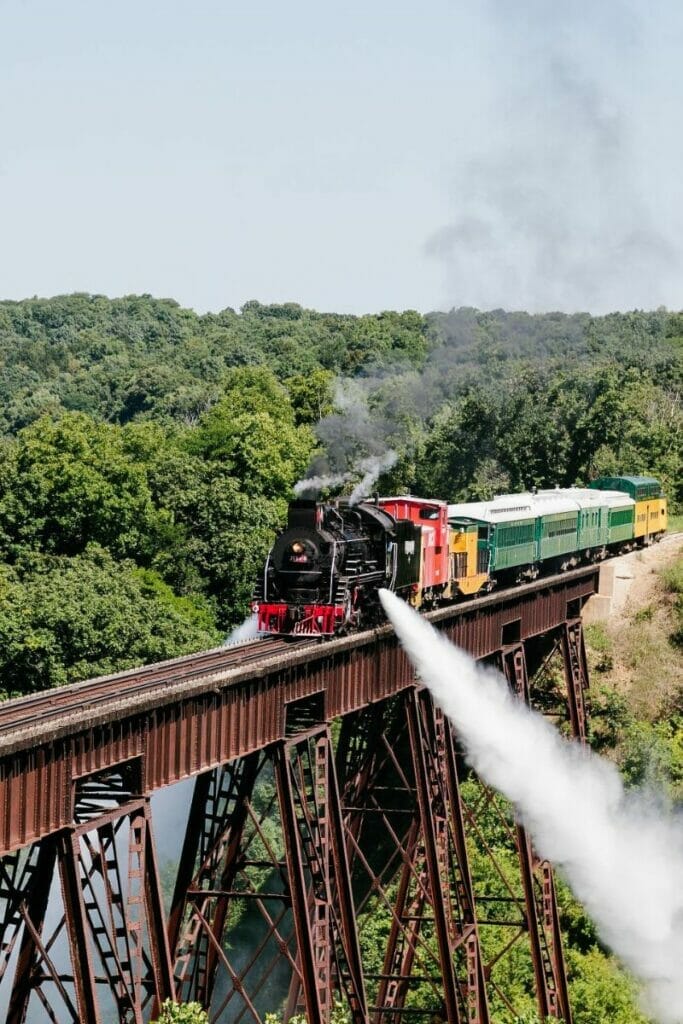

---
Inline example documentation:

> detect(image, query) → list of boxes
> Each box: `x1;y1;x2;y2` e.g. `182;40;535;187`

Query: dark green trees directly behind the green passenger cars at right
416;366;683;508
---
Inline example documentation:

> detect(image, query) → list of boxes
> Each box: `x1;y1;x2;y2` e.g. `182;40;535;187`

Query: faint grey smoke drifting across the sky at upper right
426;0;683;313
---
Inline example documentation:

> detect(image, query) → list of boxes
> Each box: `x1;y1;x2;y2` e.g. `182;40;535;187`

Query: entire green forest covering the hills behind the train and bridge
0;294;683;1024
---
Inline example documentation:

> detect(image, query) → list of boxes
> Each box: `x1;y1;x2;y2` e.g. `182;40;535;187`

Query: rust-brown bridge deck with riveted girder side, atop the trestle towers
0;566;599;856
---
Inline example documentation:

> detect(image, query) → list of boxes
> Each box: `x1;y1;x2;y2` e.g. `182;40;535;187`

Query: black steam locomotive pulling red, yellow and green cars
252;476;667;638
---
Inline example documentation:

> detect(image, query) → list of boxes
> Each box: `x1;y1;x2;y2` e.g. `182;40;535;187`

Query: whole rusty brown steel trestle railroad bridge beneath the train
0;567;599;1024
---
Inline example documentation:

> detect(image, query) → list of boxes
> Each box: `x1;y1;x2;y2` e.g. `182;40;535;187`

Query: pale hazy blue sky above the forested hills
0;0;683;312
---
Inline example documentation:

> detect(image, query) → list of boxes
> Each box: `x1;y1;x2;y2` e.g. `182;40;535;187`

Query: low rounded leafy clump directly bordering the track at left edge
0;544;220;695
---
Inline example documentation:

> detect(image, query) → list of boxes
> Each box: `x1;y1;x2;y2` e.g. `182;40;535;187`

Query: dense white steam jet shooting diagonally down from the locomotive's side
380;591;683;1024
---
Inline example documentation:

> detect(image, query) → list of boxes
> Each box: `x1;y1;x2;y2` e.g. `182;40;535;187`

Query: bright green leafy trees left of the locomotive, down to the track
0;368;313;693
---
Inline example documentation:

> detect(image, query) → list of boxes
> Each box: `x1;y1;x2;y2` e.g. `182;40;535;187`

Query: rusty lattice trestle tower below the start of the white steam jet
340;687;488;1024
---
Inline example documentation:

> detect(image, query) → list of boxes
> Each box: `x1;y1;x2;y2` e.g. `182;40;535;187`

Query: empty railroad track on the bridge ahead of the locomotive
0;637;309;736
